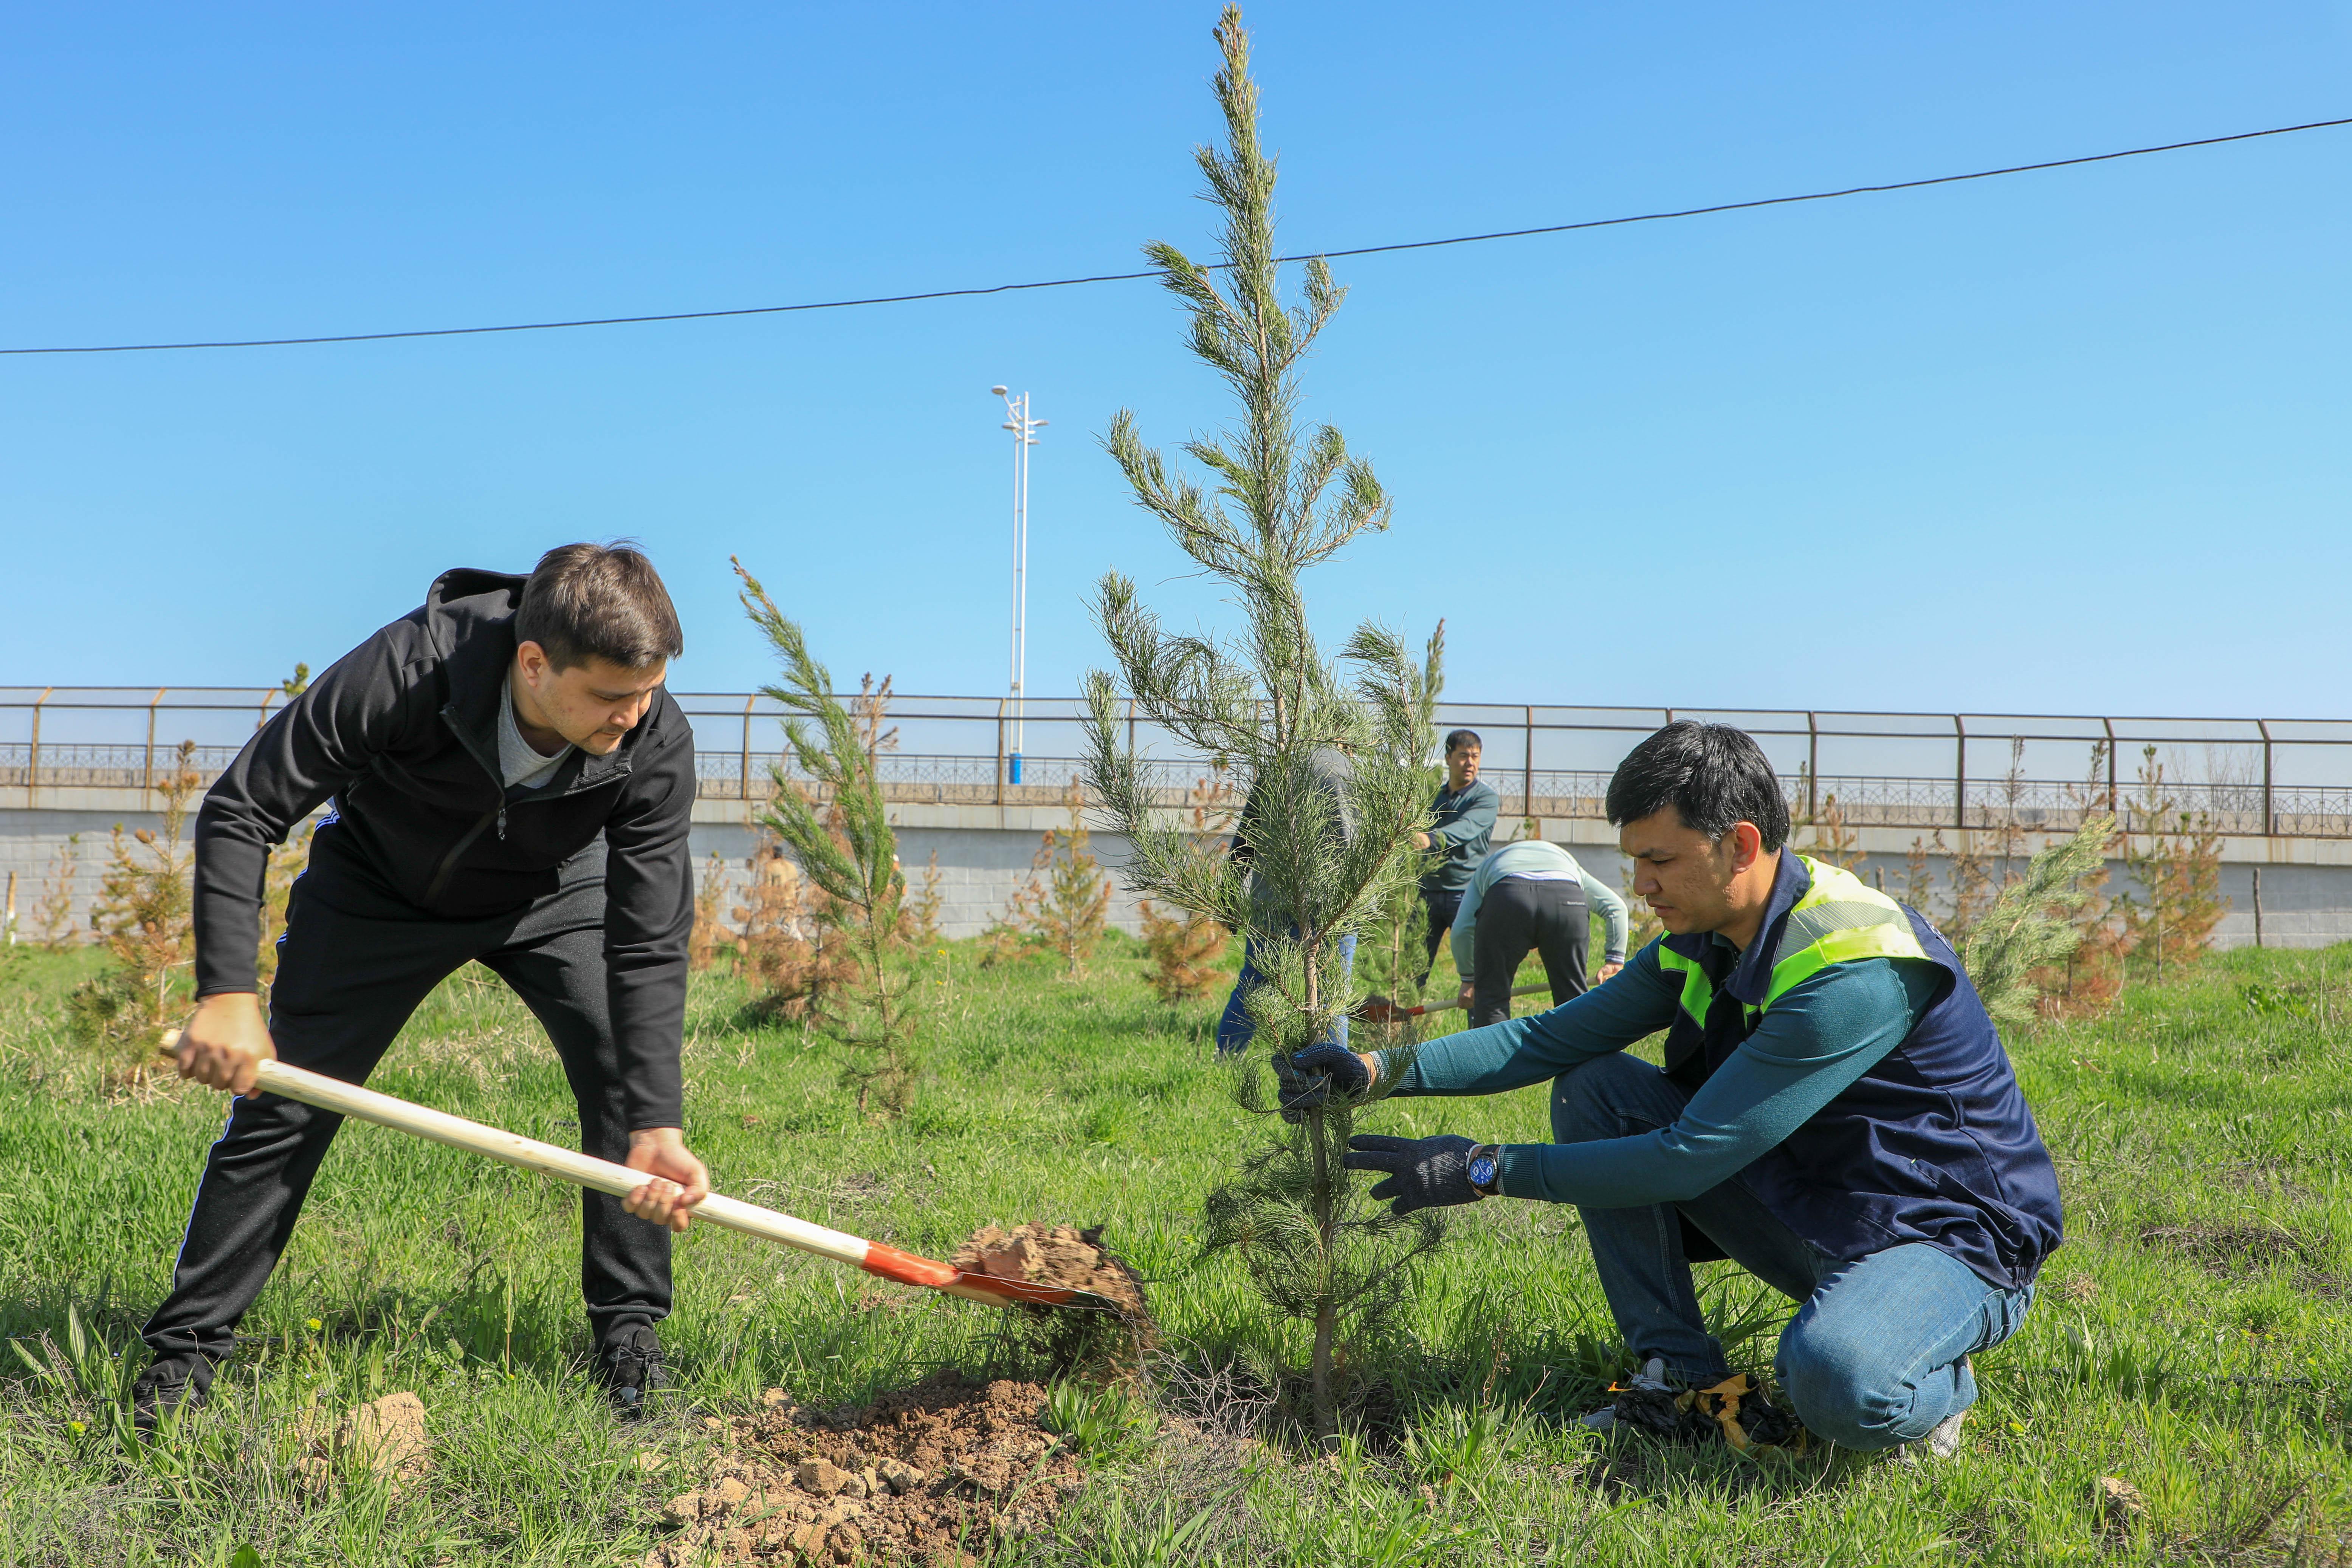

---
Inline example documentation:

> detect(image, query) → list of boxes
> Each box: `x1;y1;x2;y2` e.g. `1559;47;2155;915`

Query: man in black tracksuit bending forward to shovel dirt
134;545;710;1422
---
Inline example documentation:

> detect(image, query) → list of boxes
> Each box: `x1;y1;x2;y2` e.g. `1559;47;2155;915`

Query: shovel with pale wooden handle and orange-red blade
162;1030;1117;1312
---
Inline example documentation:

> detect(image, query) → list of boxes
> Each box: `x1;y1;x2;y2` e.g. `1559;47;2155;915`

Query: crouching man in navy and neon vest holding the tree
1282;722;2060;1455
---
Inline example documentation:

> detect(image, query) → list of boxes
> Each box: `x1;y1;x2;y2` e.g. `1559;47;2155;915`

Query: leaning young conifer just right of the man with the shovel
734;562;922;1117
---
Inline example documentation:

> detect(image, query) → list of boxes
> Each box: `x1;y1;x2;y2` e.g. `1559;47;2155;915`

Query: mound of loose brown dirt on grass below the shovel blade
645;1371;1082;1568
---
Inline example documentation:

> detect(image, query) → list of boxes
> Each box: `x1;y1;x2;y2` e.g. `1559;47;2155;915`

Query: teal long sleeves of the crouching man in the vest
1381;943;1943;1209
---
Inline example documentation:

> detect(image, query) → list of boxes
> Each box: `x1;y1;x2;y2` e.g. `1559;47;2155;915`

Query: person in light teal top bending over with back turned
1453;839;1630;1027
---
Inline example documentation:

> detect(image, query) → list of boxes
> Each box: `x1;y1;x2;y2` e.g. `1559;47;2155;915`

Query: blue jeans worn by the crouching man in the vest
1553;1053;2034;1450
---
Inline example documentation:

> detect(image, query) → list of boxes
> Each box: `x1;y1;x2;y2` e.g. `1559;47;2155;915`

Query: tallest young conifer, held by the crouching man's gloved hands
1087;7;1437;1441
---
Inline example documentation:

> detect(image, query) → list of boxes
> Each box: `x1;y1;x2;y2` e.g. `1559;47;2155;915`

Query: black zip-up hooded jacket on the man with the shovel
195;567;694;1131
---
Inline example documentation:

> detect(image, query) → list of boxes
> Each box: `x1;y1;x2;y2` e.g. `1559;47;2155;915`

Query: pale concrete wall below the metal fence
14;790;2352;947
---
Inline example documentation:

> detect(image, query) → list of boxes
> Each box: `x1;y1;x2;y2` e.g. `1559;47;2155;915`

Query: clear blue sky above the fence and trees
0;0;2352;717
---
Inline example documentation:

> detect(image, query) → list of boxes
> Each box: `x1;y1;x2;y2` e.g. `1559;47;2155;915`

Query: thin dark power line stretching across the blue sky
0;118;2352;355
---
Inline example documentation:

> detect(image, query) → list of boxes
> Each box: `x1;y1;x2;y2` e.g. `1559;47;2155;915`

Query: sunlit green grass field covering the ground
0;938;2352;1566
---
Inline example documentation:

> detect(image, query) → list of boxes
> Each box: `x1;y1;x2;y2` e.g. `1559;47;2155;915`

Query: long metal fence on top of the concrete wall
0;686;2352;837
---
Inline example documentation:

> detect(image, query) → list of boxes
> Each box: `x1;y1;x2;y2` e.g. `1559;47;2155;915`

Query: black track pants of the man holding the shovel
144;841;670;1382
